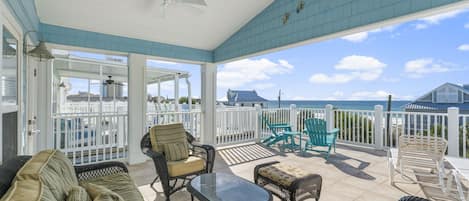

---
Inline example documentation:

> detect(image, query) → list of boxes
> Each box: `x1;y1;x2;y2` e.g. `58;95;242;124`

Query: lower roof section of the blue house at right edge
404;101;469;114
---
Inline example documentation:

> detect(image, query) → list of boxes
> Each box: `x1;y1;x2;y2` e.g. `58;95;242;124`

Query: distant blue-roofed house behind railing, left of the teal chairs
226;89;268;106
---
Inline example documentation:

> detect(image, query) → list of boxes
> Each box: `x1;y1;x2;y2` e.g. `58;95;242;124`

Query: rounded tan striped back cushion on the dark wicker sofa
15;150;78;201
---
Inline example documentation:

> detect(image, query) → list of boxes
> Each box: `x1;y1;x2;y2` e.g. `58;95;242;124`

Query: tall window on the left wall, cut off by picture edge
1;27;18;105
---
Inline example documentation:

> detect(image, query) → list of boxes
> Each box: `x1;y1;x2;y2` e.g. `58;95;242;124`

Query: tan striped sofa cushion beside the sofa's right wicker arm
80;173;143;201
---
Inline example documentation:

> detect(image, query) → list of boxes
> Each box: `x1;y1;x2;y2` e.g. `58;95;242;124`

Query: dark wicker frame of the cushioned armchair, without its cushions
140;124;215;201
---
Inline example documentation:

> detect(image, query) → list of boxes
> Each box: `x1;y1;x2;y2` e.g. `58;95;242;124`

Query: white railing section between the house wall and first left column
52;113;128;164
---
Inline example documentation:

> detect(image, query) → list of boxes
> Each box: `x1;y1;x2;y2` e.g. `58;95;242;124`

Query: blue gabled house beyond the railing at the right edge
404;83;469;114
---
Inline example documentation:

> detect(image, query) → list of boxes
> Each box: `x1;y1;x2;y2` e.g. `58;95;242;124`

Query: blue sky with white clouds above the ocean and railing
65;10;469;100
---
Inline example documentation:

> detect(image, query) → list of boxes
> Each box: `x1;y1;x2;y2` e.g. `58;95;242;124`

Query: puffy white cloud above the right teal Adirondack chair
309;55;386;84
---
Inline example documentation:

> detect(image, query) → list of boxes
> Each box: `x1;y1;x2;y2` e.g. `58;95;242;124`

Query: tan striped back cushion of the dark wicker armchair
150;123;187;152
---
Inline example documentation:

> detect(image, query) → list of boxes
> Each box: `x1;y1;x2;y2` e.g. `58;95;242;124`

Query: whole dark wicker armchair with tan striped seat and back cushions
140;123;215;201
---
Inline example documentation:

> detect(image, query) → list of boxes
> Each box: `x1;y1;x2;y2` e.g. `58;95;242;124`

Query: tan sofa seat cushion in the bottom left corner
0;179;42;201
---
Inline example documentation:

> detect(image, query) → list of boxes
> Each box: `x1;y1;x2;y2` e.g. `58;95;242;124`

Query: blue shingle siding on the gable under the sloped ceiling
214;0;462;62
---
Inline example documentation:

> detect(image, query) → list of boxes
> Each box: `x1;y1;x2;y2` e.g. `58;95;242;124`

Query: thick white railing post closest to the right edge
448;107;459;157
